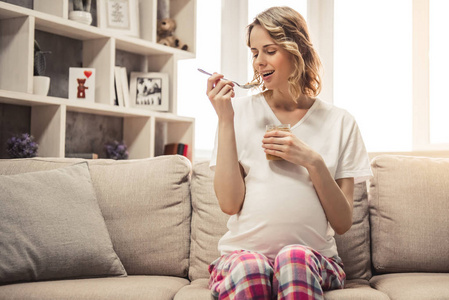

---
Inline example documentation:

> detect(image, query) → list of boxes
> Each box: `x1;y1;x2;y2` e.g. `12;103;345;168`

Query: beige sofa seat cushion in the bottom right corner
370;273;449;300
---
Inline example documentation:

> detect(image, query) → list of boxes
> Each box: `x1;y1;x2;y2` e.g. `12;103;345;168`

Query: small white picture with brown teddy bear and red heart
69;68;95;102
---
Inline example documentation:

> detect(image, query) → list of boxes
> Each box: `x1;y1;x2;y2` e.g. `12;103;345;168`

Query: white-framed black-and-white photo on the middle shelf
129;72;169;111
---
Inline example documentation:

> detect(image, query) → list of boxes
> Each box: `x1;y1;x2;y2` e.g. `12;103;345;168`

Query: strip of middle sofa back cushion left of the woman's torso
189;161;229;280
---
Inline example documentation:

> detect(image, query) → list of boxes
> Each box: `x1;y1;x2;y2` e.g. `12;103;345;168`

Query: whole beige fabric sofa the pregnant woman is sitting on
0;155;449;300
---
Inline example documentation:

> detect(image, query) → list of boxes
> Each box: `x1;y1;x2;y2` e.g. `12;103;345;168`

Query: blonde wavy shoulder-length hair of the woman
246;7;322;101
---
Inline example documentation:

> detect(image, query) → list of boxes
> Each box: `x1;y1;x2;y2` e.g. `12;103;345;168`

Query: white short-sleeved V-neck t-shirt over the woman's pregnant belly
210;94;372;259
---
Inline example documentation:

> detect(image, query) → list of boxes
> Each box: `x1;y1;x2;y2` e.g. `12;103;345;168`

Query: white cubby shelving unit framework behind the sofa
0;0;196;160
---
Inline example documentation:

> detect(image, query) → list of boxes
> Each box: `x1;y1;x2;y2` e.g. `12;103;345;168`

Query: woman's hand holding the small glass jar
262;130;318;168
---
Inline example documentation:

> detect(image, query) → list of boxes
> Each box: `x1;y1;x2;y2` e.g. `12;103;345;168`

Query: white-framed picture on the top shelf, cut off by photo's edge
97;0;140;37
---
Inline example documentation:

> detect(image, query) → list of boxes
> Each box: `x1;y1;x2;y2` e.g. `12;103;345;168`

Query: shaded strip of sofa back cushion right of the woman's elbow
335;182;371;280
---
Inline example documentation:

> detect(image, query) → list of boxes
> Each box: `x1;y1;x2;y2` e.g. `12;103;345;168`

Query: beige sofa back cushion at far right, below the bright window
369;155;449;273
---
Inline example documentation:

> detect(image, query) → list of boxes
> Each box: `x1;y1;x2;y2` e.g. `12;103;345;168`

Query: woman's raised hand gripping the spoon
207;73;235;120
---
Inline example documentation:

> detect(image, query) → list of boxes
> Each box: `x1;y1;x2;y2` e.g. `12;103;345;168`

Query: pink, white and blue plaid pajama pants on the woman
209;245;346;300
